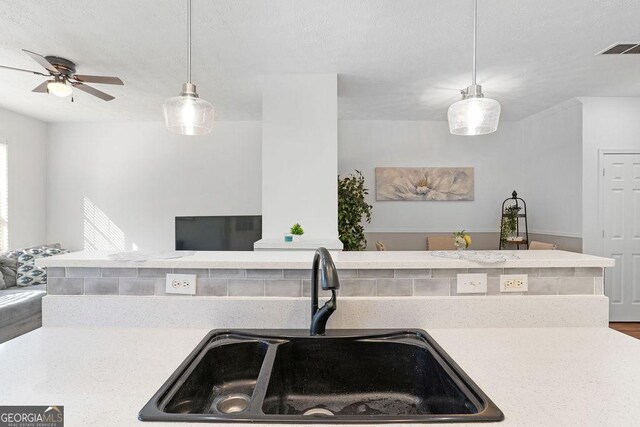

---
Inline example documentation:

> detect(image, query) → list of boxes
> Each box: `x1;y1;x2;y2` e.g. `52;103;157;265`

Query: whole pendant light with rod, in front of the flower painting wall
447;0;500;135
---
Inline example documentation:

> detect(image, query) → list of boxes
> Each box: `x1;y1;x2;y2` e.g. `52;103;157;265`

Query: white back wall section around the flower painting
338;121;525;232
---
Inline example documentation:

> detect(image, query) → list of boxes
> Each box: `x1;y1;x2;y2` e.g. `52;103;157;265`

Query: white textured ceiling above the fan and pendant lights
0;0;640;122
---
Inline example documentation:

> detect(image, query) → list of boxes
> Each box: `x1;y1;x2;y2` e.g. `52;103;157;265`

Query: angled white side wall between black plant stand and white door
519;99;582;238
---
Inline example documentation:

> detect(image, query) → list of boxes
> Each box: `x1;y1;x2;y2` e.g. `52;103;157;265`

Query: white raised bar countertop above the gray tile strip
38;250;614;269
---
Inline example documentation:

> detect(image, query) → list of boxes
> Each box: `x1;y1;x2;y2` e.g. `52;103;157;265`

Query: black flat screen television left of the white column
176;215;262;251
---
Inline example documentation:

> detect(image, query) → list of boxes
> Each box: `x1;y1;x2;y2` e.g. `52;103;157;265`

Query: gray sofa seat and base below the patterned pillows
0;285;46;343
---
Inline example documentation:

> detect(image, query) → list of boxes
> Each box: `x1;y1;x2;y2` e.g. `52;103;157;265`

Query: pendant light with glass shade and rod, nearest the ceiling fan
162;0;213;135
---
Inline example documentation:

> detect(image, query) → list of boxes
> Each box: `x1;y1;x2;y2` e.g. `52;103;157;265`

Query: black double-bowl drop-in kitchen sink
139;330;504;424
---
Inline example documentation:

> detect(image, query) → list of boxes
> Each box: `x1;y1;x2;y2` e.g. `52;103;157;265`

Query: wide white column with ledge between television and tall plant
255;74;342;249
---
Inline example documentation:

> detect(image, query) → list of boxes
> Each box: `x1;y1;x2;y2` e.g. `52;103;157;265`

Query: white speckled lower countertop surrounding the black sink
0;327;640;427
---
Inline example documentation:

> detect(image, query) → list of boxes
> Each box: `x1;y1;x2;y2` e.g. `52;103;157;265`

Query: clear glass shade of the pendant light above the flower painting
447;98;500;135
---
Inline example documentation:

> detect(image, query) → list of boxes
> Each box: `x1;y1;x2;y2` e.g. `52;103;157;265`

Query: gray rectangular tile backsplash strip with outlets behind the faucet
47;267;604;298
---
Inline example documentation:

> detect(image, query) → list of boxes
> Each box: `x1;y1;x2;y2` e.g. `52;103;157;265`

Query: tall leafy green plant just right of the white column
338;170;373;251
